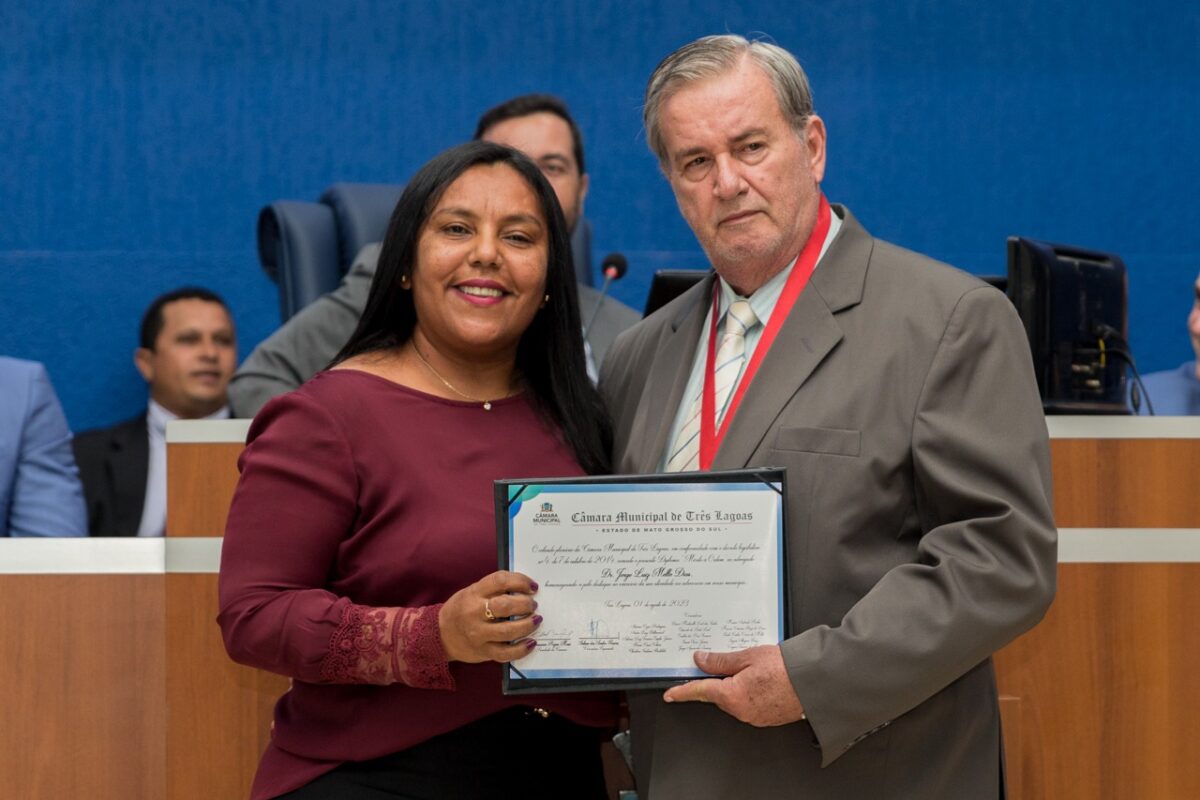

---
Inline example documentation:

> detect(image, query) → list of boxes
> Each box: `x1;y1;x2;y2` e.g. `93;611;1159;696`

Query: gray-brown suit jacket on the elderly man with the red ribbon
600;207;1057;800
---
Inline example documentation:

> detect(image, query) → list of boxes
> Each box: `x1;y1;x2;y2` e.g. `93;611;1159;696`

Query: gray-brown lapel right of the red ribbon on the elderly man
713;206;872;469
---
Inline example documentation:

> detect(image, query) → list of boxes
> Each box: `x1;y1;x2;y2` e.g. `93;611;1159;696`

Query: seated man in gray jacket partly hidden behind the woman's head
229;95;640;416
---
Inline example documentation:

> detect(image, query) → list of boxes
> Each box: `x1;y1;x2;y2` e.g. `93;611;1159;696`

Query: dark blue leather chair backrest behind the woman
258;184;593;321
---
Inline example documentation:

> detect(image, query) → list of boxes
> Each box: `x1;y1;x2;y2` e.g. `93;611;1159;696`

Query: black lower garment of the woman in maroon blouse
280;706;608;800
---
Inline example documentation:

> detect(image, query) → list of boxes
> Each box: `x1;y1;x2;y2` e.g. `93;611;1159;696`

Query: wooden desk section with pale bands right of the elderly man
996;417;1200;800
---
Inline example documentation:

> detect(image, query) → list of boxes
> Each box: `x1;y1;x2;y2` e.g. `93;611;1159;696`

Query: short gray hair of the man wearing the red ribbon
642;34;812;167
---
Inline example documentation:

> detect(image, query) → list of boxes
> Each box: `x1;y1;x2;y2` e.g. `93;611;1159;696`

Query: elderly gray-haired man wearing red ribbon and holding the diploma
600;36;1057;800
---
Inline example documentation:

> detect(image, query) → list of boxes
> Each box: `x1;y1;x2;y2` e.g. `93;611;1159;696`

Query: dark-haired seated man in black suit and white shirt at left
74;287;238;536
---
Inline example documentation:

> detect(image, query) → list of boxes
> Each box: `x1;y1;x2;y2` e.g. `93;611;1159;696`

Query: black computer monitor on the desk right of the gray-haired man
1008;236;1130;414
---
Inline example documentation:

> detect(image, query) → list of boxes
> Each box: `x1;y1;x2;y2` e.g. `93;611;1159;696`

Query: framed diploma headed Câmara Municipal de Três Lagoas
496;469;787;694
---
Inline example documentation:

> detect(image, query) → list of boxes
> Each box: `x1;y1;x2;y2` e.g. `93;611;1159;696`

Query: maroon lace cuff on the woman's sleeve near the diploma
320;603;455;690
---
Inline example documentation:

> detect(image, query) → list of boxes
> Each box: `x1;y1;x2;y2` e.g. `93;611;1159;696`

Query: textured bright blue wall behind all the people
0;0;1200;429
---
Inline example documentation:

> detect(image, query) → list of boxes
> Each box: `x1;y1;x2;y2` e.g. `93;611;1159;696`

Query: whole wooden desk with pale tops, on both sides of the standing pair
0;417;1200;800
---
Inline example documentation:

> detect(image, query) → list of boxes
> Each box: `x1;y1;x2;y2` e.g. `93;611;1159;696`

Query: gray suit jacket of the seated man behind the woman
229;243;638;417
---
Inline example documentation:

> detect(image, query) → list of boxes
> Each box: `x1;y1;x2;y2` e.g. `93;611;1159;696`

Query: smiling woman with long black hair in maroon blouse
218;142;616;800
